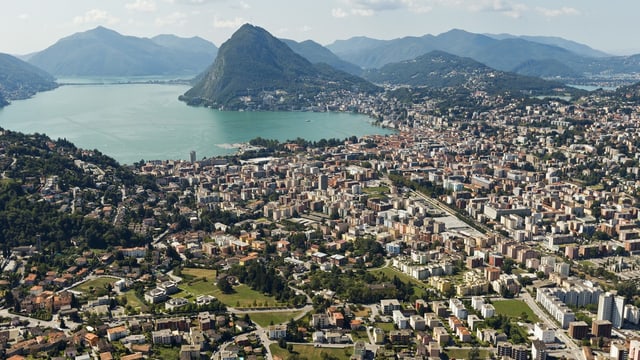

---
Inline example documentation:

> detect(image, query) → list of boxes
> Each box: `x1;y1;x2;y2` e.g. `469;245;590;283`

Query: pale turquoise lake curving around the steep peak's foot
0;84;392;164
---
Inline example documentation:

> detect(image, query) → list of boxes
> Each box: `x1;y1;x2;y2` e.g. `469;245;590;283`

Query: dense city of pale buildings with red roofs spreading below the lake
0;85;640;360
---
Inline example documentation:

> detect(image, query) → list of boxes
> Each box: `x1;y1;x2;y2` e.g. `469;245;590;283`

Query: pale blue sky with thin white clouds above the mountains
5;0;640;55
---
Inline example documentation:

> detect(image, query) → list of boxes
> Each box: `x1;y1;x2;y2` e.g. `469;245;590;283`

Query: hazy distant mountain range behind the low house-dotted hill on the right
327;29;640;78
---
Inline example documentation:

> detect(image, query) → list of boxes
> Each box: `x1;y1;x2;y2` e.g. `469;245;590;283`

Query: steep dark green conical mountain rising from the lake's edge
180;24;379;109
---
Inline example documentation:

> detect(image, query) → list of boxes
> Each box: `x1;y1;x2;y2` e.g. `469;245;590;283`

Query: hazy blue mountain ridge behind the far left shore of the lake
29;26;215;76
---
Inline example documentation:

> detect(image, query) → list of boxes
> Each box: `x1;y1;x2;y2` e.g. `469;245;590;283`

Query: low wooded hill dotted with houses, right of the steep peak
365;51;564;94
